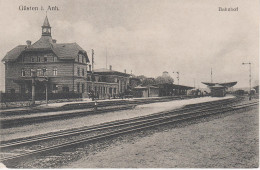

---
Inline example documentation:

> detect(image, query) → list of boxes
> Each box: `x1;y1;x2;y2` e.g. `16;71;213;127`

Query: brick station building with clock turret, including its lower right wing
2;16;130;99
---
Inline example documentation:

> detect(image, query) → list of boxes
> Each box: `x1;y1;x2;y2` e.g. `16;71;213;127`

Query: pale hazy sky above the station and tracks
0;0;260;90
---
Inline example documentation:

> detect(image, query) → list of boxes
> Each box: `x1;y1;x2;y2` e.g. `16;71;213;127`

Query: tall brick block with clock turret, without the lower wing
2;16;89;93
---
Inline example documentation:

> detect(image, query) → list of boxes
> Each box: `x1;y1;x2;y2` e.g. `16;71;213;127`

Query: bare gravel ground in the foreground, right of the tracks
62;106;259;168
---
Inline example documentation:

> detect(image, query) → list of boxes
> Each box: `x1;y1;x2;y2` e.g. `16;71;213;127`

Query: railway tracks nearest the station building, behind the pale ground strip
0;96;196;129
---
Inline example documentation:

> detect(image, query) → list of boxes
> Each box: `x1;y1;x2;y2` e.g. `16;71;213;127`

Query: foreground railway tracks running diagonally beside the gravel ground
1;99;258;166
